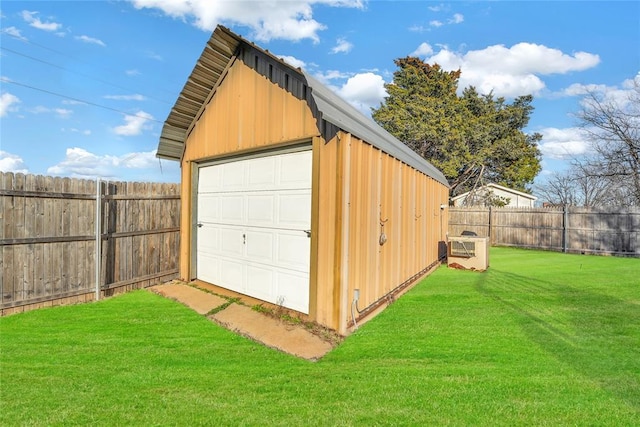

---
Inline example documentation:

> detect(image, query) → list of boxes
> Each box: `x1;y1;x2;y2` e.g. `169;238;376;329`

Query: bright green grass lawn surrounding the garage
0;248;640;426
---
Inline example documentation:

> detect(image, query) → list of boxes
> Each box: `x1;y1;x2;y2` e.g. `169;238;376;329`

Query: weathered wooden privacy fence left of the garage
0;173;180;315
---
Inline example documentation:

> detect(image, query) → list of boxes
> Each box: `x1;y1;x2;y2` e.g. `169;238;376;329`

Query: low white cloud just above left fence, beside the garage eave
47;147;158;178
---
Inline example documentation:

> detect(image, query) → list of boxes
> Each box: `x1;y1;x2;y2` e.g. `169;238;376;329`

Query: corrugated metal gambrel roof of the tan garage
157;26;449;186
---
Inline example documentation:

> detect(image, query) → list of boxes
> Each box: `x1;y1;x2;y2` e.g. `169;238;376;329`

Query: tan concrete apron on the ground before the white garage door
148;282;333;361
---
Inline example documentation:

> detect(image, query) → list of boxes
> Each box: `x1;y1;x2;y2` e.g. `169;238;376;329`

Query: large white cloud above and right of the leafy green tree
425;43;600;97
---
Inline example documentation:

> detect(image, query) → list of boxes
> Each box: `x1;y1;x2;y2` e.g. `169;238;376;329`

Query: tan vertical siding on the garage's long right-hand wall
315;132;448;333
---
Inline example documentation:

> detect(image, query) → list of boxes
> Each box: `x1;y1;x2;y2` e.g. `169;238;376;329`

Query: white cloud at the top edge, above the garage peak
132;0;364;42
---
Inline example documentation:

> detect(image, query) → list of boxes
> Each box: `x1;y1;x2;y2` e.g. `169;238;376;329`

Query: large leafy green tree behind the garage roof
372;57;542;196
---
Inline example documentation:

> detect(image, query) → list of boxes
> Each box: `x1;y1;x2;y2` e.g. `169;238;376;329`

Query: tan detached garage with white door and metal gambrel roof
158;26;449;334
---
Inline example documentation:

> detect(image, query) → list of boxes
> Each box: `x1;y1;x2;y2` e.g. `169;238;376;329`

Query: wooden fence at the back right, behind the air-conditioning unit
449;207;640;257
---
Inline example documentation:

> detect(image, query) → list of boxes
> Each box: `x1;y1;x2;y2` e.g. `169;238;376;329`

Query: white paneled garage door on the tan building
196;151;311;314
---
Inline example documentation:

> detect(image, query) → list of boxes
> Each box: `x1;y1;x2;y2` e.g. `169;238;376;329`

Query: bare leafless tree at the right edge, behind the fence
574;77;640;205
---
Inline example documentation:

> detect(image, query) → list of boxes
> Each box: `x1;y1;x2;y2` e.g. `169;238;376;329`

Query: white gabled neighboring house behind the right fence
451;184;537;208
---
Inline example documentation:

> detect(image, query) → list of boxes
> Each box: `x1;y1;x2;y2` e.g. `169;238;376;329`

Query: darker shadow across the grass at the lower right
476;271;640;410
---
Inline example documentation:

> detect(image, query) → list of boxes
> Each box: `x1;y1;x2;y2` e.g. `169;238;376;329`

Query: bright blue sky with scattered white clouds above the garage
0;0;640;187
